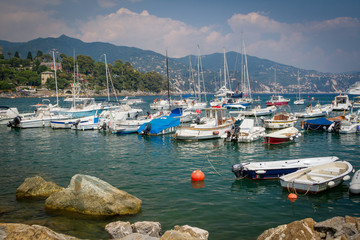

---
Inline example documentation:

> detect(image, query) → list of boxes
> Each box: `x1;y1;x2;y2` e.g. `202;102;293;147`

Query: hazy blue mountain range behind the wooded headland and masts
0;35;360;93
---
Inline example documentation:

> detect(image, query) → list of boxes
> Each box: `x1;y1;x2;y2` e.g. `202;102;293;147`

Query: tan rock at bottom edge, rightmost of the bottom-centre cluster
160;225;209;240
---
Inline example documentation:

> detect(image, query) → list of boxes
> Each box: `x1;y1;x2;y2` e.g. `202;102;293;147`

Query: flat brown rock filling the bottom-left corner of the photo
0;223;78;240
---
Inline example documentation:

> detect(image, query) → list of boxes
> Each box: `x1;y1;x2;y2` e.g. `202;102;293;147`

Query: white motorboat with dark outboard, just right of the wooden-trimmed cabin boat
221;119;265;142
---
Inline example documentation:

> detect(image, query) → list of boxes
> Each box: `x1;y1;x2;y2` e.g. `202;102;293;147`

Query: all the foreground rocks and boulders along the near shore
4;174;360;240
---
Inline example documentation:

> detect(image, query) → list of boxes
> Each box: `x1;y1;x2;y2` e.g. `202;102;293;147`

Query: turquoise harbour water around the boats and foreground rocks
0;95;360;239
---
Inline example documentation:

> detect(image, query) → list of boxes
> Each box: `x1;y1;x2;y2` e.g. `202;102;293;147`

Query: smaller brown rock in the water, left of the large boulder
16;176;63;199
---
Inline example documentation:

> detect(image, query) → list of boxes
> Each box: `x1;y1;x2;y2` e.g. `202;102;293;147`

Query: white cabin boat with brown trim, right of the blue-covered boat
174;107;235;141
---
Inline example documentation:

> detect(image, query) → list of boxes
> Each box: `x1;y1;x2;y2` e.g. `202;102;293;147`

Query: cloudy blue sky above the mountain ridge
0;0;360;73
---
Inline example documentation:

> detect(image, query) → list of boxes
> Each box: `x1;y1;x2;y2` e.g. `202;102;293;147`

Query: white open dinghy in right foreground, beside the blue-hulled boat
280;161;353;194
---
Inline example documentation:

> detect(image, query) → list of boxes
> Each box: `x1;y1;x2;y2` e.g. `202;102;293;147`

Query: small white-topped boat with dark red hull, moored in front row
264;127;301;144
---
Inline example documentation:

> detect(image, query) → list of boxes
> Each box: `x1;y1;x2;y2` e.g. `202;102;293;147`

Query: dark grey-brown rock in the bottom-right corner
314;216;360;239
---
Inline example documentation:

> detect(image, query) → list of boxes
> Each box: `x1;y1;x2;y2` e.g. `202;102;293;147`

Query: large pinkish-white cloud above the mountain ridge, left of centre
79;8;227;57
